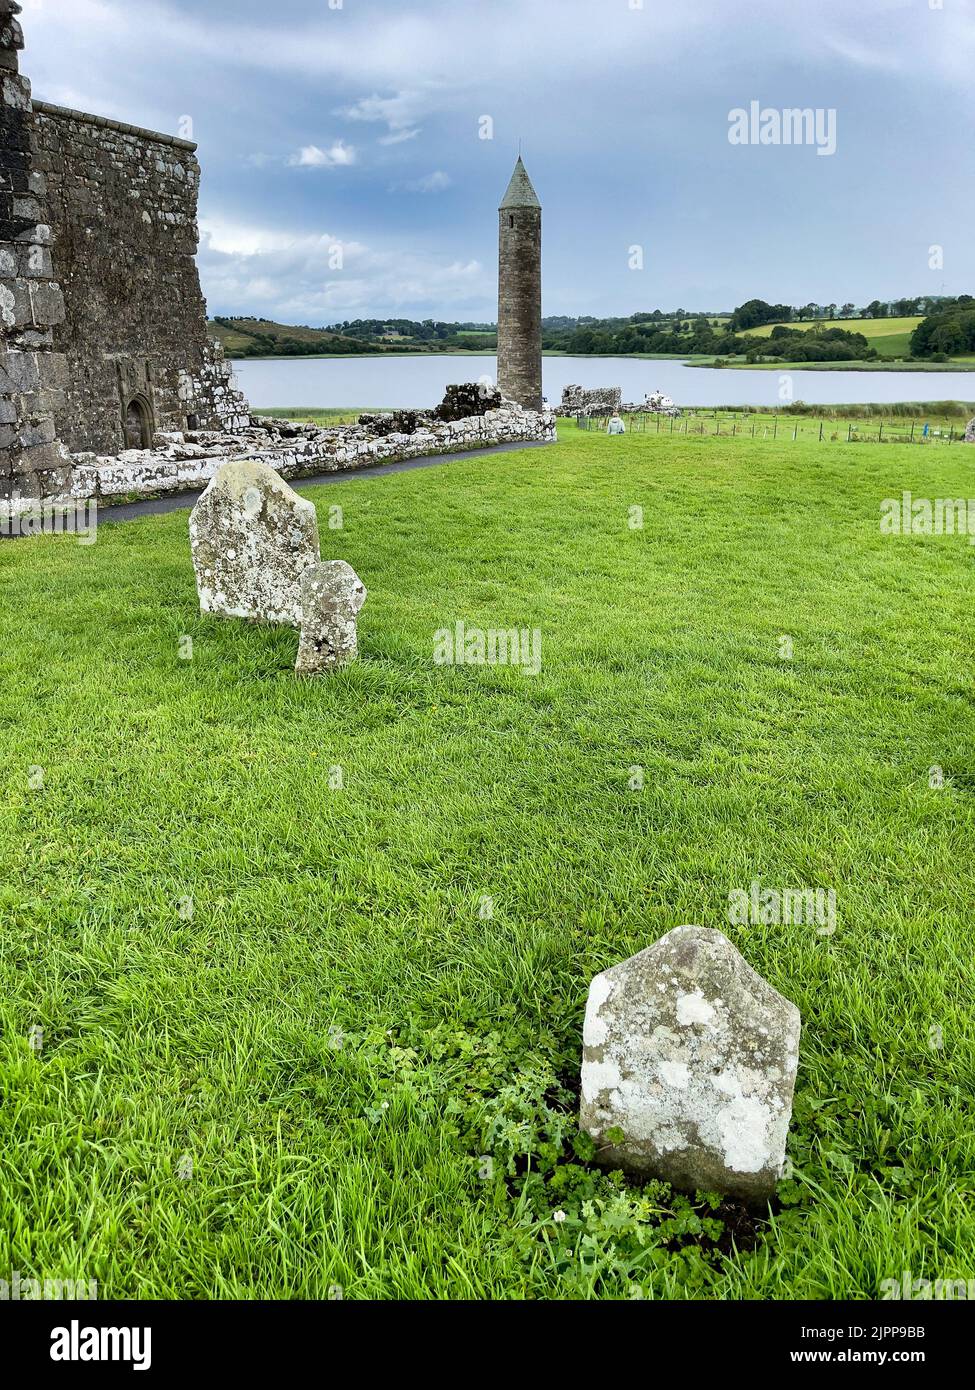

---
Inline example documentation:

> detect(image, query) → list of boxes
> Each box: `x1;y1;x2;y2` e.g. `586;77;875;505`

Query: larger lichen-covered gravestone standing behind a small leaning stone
189;460;315;627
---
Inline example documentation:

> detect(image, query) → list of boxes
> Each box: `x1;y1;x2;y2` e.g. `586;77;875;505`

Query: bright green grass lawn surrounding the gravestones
0;425;975;1298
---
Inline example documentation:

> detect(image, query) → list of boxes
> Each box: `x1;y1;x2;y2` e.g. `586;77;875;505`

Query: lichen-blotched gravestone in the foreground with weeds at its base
581;927;800;1201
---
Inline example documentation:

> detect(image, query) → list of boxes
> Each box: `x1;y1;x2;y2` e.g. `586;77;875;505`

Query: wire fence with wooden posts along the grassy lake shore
574;410;965;443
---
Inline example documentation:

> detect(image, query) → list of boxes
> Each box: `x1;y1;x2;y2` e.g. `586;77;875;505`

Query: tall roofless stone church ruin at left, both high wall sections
0;0;249;500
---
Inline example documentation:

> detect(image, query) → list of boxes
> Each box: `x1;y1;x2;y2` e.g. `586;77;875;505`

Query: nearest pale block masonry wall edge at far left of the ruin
0;0;71;505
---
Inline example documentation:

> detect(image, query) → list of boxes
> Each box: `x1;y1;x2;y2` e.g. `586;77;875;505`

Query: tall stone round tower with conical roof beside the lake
498;156;541;410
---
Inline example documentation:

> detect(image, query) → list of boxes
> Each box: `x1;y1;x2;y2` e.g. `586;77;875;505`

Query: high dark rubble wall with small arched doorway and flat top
33;101;248;453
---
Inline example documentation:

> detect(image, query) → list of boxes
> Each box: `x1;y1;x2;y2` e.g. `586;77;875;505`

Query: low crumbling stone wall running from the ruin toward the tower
71;406;555;502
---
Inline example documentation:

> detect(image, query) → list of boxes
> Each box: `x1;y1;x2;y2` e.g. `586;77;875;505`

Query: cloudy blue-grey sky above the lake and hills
22;0;975;325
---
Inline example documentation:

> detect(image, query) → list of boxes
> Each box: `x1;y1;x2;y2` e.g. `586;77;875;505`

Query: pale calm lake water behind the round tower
234;354;975;410
